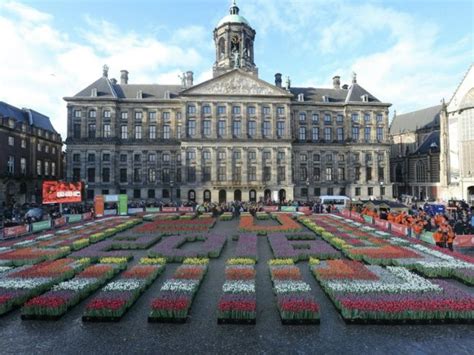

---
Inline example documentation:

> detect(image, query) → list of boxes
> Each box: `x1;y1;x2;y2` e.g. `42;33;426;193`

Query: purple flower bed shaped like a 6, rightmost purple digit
268;234;340;262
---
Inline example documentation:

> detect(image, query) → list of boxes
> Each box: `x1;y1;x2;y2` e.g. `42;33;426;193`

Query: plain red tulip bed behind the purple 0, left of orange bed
132;217;216;234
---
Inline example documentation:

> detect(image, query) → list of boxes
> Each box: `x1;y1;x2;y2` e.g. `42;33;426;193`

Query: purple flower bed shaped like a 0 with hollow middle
148;234;227;262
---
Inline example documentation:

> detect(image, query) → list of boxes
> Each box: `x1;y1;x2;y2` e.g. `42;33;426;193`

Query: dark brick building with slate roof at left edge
0;102;63;207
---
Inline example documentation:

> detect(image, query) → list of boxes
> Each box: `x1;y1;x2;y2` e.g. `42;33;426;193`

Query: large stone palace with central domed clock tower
65;4;392;202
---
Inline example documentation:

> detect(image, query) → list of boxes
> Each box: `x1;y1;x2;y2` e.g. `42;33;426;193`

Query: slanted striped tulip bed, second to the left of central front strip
82;258;166;322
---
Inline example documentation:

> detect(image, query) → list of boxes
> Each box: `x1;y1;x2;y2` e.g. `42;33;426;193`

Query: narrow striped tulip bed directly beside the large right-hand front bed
269;259;320;324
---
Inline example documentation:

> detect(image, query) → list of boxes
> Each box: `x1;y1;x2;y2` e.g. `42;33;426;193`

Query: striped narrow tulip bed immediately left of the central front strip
148;258;209;323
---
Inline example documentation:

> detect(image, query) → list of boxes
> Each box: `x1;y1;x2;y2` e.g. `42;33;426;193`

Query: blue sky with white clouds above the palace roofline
0;0;474;136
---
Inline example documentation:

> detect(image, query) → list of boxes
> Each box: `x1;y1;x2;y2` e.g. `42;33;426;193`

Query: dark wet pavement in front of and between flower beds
0;221;474;354
